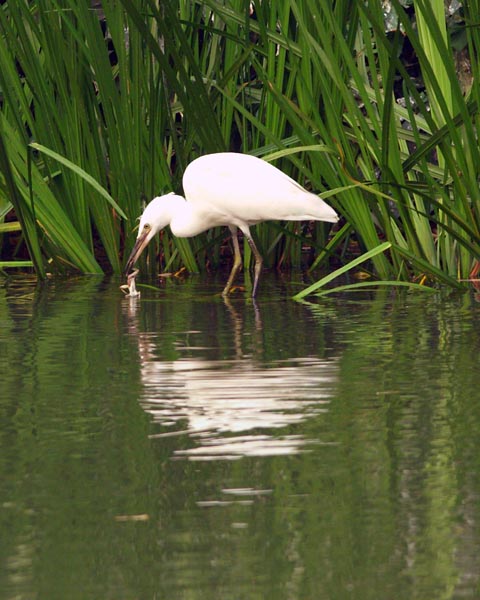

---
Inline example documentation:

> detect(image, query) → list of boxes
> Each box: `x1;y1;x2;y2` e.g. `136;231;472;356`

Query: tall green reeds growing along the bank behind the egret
0;0;480;286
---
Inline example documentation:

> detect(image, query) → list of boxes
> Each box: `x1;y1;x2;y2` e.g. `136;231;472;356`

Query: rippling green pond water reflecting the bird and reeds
0;274;480;600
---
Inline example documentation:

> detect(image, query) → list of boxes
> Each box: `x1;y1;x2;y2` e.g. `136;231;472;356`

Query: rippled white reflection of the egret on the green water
125;299;337;460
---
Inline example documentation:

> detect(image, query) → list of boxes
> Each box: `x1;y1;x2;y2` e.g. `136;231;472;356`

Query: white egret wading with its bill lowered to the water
126;152;338;296
